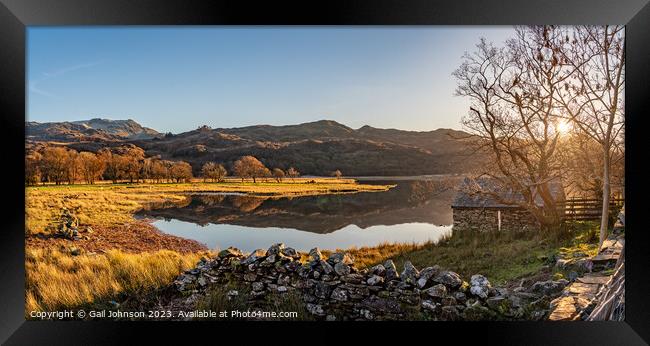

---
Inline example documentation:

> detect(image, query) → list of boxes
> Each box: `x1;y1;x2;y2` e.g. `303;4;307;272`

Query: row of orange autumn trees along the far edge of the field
25;146;330;185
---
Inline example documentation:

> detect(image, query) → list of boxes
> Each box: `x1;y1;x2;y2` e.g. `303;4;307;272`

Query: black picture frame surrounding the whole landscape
0;0;650;345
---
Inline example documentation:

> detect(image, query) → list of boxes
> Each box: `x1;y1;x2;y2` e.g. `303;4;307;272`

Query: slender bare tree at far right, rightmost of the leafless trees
552;26;625;246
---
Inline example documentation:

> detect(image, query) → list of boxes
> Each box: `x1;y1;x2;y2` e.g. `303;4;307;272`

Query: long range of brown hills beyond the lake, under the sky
27;119;480;176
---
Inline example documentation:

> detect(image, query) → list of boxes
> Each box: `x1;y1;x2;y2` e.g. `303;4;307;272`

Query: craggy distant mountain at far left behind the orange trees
25;118;162;142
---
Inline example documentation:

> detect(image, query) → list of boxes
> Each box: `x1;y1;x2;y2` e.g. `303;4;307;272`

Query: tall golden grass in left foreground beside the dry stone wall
25;249;201;314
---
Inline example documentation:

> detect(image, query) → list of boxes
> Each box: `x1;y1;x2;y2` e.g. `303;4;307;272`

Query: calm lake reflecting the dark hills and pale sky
136;178;453;251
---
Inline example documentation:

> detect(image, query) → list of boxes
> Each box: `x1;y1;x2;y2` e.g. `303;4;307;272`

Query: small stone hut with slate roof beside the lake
451;178;565;232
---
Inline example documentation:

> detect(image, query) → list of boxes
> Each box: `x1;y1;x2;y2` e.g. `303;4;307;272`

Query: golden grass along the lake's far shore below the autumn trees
25;178;391;234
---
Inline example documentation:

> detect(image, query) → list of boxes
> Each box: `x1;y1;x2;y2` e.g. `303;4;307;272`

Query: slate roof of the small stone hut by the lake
451;177;565;208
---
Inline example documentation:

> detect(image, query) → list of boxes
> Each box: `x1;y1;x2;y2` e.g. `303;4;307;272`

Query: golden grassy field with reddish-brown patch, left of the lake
25;178;390;313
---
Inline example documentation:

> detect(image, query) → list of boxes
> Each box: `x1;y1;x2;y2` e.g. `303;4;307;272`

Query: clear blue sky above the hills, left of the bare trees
26;26;514;133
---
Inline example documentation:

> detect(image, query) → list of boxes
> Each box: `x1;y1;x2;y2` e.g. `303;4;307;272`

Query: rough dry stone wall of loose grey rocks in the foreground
173;244;548;320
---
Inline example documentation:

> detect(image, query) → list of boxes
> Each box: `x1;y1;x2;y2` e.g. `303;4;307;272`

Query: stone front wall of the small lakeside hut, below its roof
453;208;539;232
